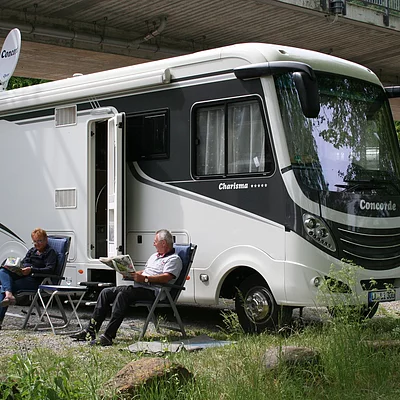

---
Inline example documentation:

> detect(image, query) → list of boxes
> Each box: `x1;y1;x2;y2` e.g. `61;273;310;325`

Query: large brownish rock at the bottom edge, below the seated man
102;358;192;399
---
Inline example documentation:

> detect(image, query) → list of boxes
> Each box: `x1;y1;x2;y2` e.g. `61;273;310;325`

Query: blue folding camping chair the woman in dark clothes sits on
20;236;71;329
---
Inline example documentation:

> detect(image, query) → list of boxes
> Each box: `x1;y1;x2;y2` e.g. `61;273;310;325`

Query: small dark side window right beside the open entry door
126;110;169;161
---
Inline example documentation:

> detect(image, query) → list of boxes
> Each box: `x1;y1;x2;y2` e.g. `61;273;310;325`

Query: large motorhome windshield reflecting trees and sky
275;73;400;195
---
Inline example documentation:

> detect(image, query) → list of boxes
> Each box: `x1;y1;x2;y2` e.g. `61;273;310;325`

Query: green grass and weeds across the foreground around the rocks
0;312;400;400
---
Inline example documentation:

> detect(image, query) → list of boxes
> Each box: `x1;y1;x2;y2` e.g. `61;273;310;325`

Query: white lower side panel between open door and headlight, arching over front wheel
123;165;286;304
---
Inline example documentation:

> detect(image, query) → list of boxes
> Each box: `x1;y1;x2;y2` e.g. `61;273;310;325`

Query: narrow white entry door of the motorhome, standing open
107;113;125;257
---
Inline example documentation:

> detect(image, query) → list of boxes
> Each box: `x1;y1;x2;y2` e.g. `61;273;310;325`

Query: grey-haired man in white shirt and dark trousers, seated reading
70;229;182;346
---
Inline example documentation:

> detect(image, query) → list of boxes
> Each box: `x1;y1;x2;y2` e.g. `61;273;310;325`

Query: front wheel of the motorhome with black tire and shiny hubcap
235;275;293;333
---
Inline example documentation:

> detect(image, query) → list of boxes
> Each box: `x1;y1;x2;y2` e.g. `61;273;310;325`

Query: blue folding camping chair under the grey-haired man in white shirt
132;244;197;340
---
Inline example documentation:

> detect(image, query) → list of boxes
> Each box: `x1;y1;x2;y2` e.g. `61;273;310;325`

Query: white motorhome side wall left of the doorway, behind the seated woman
0;109;97;284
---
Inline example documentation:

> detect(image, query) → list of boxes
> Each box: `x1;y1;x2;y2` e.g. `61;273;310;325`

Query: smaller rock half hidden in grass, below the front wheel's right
263;346;320;370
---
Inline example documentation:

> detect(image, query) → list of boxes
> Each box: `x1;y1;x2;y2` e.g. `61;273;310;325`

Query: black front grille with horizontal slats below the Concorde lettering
337;227;400;270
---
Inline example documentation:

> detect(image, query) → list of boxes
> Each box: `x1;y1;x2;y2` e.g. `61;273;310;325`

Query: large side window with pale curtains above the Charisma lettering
194;100;273;177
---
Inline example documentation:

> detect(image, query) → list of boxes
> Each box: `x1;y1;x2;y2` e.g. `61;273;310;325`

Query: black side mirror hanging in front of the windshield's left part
293;72;320;118
